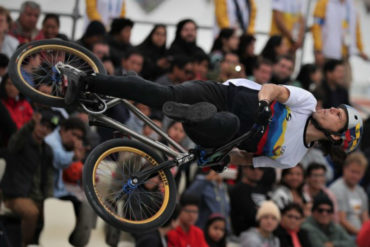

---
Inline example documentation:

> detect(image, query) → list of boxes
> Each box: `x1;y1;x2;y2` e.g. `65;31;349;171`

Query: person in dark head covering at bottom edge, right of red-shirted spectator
204;213;227;247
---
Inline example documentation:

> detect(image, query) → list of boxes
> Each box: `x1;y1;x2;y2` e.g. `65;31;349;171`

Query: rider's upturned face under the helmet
313;107;347;132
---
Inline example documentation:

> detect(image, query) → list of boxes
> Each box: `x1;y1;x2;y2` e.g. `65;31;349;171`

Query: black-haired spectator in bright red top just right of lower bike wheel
167;194;208;247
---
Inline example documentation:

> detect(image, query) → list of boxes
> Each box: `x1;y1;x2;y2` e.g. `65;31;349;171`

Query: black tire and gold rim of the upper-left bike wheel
8;39;106;107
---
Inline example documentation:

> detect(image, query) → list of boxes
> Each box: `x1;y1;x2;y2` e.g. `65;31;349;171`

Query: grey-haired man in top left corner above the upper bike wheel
10;1;41;44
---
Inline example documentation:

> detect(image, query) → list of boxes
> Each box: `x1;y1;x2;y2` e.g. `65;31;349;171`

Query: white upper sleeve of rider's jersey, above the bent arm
283;85;317;114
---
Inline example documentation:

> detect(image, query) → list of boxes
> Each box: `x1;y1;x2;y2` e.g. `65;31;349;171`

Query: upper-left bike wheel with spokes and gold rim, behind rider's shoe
8;39;106;107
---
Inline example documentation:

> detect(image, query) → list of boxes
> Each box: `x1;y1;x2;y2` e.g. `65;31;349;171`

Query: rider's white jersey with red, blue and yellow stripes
224;79;317;168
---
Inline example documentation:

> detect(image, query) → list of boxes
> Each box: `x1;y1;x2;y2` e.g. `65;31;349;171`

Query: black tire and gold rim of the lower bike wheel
83;139;176;232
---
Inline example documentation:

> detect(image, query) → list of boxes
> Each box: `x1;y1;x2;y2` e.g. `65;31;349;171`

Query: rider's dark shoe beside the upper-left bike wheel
59;66;86;105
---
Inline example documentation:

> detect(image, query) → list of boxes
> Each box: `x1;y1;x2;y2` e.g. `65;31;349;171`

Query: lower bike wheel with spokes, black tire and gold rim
83;139;176;232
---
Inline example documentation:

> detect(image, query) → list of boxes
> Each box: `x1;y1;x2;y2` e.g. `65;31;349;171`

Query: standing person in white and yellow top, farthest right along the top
312;0;368;79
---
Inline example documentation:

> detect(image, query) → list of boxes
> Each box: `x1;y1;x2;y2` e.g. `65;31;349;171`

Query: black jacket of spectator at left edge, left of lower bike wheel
1;121;54;200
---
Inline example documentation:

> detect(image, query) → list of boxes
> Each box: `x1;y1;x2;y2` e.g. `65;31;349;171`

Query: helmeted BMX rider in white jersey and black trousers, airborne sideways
61;64;363;169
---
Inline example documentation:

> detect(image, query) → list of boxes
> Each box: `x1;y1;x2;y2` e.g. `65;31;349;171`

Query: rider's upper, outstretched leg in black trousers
83;75;227;110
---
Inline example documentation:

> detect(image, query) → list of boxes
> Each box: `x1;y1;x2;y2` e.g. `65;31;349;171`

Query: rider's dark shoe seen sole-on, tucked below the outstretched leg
162;101;217;123
